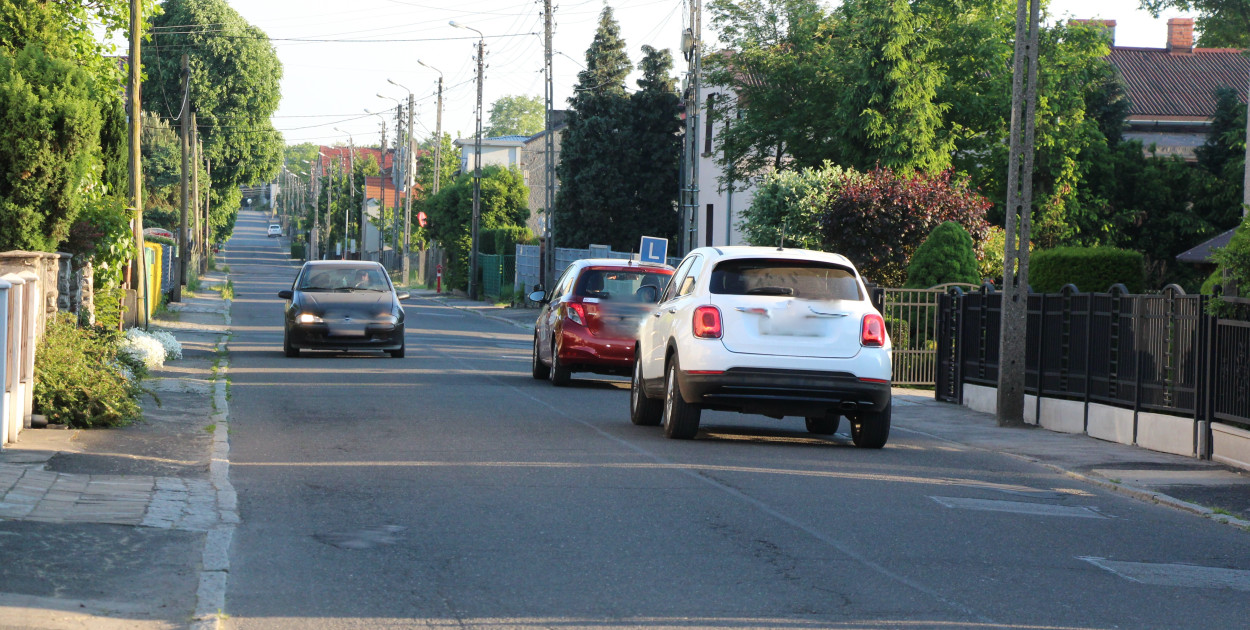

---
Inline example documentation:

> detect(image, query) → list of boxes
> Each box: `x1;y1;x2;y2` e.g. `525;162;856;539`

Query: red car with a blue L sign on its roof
530;259;673;385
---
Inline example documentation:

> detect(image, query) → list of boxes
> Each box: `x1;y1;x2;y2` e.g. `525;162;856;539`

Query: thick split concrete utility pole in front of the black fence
998;0;1041;426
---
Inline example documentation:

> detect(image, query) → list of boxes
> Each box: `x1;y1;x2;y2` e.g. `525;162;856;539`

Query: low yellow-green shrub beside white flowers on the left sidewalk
34;316;146;429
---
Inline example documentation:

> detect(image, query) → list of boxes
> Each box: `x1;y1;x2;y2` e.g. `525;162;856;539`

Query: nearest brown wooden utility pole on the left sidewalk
126;0;150;329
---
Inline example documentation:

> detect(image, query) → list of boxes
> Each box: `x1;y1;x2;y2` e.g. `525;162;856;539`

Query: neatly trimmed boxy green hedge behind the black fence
1029;248;1146;294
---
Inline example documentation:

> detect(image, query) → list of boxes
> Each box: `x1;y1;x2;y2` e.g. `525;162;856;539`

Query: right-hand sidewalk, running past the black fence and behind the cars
411;289;1250;531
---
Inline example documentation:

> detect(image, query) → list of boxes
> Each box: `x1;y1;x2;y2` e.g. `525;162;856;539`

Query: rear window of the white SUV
710;259;864;300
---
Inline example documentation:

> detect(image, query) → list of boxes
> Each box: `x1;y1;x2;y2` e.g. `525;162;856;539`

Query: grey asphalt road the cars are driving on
225;213;1250;629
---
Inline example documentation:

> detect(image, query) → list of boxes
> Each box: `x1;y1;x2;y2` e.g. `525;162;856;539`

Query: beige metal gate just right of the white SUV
873;283;976;388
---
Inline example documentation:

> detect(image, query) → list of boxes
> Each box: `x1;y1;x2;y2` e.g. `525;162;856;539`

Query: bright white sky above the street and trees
200;0;1183;144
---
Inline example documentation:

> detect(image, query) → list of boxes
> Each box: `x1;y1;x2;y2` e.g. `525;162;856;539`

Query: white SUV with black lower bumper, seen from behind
630;246;891;449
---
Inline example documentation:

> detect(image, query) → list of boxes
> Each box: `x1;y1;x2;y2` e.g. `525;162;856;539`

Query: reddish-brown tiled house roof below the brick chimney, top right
1108;46;1250;120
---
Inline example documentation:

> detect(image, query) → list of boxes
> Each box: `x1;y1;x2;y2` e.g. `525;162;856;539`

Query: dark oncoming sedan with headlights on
278;260;408;359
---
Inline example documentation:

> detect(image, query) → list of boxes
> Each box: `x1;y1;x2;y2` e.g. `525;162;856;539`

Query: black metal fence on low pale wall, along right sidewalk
935;285;1250;426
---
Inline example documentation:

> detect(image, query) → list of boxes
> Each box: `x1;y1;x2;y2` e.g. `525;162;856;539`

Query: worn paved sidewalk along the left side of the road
0;273;238;629
